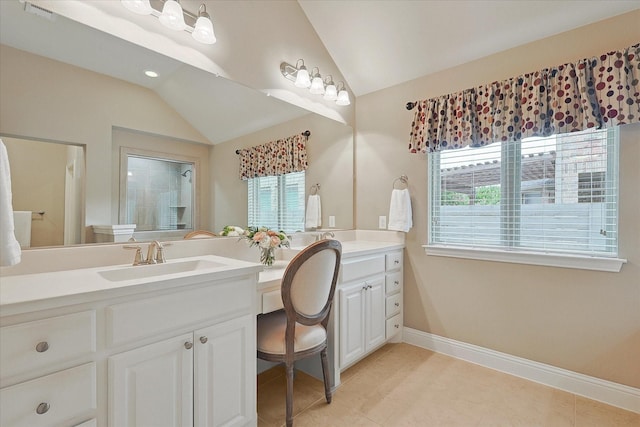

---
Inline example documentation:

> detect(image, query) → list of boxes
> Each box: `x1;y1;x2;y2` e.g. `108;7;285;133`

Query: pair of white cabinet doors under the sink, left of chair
108;315;255;427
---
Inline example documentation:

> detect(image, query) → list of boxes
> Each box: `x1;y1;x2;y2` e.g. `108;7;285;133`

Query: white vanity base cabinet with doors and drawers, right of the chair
338;250;402;370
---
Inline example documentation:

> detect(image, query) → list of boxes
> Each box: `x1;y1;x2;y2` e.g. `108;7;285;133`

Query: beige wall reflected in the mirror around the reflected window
210;114;354;231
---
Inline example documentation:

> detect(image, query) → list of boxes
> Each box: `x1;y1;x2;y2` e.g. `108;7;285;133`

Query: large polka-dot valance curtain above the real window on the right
409;44;640;153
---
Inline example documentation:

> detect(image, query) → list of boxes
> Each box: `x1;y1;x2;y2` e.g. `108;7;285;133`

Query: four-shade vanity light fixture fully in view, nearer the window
280;59;351;105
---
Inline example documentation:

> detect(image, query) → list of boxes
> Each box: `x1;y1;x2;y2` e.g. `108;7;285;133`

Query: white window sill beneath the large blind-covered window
423;245;627;273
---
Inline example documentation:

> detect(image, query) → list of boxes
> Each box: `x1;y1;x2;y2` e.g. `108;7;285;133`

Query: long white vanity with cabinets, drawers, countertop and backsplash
0;231;404;427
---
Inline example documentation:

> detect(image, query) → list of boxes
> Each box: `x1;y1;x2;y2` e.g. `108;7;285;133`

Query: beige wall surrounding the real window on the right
355;11;640;387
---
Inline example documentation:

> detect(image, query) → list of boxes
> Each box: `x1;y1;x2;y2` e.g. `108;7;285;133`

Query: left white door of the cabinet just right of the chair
339;282;366;368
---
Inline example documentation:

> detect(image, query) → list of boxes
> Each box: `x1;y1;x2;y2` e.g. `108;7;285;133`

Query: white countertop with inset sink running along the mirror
0;240;404;315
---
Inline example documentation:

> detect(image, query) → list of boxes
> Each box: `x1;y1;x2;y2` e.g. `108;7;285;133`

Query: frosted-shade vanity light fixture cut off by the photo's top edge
120;0;216;44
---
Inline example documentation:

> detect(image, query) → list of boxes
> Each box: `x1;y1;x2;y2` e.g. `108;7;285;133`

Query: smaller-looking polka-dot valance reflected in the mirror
238;134;307;180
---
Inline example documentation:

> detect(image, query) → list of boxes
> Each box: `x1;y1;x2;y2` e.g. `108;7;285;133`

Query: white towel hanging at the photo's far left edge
0;139;22;266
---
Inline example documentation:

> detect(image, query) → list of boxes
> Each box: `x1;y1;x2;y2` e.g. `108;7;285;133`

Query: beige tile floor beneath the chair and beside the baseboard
258;344;640;427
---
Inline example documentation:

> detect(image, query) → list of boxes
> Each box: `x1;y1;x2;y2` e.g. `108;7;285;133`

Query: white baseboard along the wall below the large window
402;326;640;413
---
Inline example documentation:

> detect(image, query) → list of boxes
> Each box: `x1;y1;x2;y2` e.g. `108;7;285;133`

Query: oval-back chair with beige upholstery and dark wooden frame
257;240;342;427
